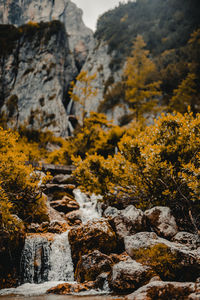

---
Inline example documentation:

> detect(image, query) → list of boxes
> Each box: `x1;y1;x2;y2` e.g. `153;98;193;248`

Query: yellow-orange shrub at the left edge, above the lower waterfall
0;128;48;231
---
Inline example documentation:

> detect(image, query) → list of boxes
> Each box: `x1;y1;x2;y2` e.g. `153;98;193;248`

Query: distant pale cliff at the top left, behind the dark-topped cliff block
0;0;93;68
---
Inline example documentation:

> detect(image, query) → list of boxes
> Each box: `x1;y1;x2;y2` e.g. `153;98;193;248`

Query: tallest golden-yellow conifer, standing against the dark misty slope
124;35;161;119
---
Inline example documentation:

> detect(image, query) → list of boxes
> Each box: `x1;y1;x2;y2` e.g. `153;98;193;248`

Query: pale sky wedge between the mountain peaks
72;0;127;30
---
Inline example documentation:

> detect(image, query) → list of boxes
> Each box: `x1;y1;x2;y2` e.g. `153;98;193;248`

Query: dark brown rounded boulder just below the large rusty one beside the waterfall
75;250;113;282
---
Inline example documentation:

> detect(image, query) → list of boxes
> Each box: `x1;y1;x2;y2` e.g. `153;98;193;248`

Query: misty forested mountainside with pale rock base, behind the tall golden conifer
73;0;200;122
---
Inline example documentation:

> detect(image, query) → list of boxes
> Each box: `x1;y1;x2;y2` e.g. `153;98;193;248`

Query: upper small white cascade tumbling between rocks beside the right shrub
73;189;102;223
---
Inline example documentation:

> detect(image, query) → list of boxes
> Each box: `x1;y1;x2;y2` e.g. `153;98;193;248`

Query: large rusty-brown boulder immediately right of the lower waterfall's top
69;218;117;266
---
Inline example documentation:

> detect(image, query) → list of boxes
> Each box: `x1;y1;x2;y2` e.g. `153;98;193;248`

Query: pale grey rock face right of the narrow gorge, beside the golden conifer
74;39;127;124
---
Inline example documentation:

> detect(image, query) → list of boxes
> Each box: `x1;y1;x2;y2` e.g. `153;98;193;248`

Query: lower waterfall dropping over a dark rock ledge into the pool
21;231;74;283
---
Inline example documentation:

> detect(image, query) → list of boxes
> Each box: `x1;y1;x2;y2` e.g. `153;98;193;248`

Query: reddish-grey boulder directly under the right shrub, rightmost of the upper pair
145;206;178;239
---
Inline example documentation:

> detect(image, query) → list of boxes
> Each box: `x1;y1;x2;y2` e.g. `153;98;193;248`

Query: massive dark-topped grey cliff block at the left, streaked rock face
0;21;77;136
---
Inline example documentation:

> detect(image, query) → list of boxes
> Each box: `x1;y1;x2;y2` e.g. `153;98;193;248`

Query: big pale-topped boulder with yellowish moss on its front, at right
125;232;200;281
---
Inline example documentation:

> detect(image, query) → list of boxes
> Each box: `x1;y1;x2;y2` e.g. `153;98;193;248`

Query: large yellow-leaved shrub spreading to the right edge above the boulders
75;112;200;219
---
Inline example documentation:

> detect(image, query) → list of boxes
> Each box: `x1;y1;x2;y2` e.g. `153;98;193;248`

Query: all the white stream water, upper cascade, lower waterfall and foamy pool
0;189;112;300
